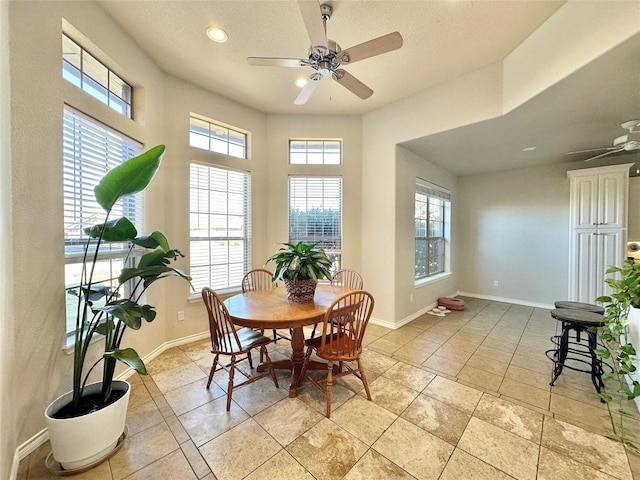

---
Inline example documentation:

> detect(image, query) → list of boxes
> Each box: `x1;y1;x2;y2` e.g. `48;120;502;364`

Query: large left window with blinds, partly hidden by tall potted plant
63;107;143;332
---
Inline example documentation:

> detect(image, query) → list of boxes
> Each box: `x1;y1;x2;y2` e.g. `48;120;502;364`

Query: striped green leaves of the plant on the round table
266;242;331;282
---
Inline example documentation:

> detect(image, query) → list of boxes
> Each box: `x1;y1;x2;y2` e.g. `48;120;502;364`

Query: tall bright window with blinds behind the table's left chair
189;163;251;291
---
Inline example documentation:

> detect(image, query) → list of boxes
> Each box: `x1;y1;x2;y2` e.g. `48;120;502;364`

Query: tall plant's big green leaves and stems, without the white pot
67;145;191;414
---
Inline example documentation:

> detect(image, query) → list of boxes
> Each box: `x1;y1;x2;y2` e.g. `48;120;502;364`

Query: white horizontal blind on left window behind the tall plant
63;107;143;256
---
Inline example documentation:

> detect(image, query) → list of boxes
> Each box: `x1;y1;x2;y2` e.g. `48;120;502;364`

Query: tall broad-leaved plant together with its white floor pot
45;145;191;472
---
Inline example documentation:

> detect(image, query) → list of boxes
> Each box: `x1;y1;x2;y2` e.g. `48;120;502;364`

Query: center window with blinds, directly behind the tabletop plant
289;176;342;270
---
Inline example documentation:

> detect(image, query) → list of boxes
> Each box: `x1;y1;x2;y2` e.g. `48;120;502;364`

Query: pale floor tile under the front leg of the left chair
178;397;249;447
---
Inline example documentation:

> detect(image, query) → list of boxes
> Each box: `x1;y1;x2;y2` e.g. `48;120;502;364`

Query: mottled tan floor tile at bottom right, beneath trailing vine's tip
542;417;632;480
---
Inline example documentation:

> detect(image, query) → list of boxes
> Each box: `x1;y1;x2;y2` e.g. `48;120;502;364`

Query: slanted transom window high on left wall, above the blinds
62;33;132;118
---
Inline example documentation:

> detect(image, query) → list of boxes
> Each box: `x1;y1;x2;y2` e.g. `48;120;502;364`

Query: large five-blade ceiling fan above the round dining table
247;0;402;105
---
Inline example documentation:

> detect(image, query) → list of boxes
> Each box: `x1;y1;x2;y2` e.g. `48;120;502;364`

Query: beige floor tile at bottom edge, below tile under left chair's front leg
199;418;282;480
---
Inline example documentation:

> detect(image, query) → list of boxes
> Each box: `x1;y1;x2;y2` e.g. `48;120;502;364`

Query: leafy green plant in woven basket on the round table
266;242;332;302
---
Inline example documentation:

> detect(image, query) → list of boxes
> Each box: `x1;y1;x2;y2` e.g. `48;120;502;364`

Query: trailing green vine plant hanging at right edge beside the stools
596;260;640;454
